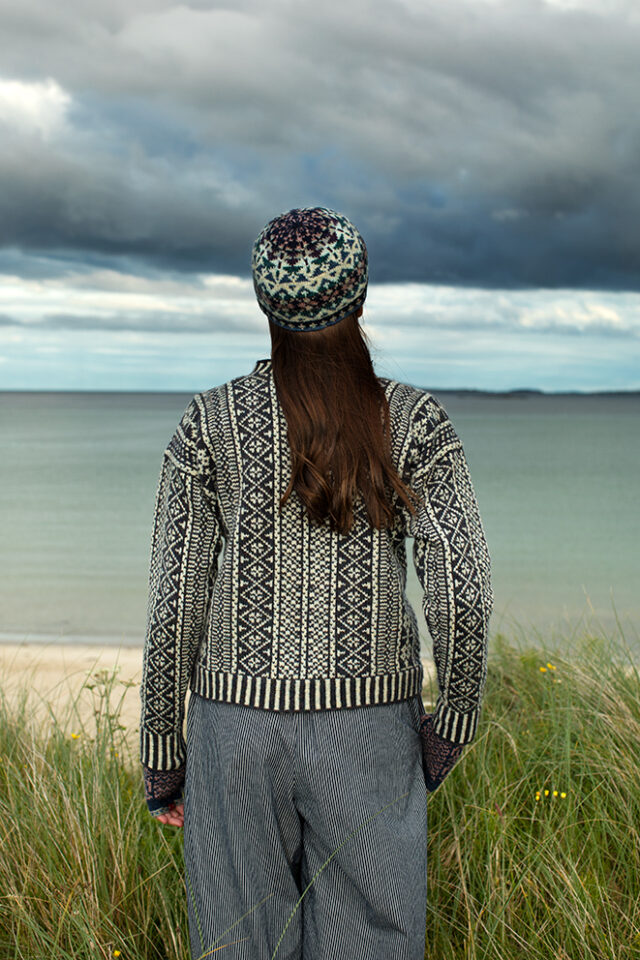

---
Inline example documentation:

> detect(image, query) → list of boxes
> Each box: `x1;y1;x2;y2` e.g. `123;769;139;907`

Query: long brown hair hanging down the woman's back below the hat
269;308;421;534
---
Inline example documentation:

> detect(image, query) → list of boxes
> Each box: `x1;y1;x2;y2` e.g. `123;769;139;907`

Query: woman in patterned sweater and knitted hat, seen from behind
140;207;493;960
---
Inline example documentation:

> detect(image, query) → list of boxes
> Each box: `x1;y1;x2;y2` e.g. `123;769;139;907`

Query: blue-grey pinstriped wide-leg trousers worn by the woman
184;693;427;960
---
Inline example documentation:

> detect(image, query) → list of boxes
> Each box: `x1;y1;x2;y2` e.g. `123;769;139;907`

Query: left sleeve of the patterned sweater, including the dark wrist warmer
140;395;222;814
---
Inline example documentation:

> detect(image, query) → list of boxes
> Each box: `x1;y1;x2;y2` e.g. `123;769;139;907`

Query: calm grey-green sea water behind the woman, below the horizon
0;391;640;651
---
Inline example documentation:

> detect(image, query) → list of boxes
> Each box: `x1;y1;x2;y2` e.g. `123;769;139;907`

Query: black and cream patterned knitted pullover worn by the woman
140;359;493;814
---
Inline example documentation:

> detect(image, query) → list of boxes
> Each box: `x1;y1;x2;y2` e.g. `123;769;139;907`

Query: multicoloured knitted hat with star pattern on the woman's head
251;207;368;331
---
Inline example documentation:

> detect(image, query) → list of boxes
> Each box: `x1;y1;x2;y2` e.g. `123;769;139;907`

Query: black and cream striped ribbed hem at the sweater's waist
190;664;423;711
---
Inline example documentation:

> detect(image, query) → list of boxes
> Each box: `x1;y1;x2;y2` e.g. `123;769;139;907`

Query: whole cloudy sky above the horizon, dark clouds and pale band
0;0;640;391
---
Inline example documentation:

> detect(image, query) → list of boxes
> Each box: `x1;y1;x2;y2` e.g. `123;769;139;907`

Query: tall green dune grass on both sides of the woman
0;612;640;960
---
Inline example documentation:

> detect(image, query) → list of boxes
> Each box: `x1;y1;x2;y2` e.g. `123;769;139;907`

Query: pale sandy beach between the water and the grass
0;643;433;750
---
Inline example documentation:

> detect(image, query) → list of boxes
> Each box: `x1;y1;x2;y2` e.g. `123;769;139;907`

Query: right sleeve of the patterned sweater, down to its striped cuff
407;394;493;744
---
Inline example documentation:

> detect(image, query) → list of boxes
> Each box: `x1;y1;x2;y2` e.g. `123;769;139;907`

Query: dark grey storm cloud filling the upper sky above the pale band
0;0;640;290
